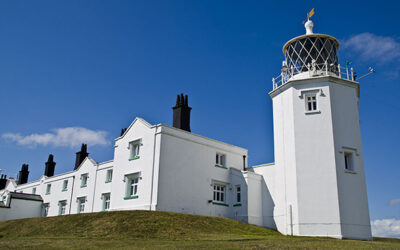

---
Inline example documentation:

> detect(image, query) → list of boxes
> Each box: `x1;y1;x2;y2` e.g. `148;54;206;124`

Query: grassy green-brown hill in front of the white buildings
0;211;400;249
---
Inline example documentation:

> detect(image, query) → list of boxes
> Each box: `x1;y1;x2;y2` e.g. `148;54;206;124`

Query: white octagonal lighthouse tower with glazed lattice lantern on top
266;20;372;240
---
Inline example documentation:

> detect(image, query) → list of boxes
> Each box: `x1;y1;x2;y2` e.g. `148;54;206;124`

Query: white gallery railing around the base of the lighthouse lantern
272;61;357;89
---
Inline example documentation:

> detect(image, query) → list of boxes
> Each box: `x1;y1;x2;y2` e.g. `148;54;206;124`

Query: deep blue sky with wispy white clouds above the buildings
0;0;400;237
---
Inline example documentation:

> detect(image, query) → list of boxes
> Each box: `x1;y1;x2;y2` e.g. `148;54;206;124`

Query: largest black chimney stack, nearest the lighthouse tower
172;94;192;132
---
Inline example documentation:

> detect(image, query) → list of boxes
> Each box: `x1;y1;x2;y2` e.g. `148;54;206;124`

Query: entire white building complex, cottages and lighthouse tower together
0;20;372;240
